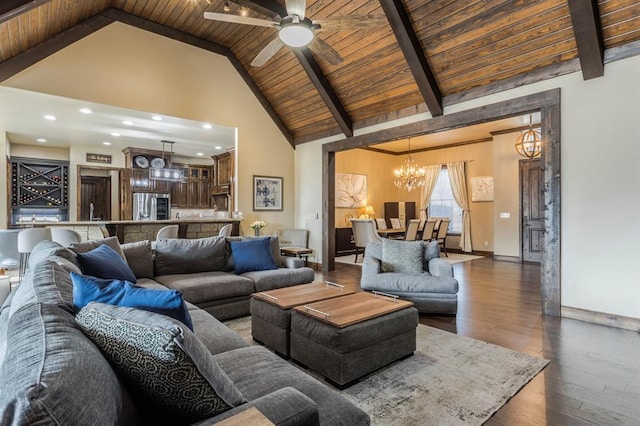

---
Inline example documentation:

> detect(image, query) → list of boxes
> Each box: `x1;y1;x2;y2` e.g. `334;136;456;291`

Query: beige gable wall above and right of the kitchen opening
4;23;296;233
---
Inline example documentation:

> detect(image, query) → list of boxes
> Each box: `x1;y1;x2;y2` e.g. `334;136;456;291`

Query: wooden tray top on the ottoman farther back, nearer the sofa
253;281;354;309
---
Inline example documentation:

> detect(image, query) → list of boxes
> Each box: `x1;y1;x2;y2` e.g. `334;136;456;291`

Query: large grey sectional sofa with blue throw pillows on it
0;237;370;425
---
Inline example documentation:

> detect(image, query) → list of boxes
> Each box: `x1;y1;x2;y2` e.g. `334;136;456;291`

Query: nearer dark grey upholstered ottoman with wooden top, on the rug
290;293;418;389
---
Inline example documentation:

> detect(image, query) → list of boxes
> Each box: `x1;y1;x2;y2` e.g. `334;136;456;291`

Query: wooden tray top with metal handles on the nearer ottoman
293;292;413;328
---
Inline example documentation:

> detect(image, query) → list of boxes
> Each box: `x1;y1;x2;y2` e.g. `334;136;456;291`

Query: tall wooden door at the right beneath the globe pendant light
520;159;544;263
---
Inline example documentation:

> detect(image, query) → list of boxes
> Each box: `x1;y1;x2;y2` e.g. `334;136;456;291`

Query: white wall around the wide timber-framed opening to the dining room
296;56;640;318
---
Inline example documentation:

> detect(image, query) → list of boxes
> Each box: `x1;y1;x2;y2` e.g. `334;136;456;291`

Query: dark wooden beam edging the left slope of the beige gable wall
0;15;113;82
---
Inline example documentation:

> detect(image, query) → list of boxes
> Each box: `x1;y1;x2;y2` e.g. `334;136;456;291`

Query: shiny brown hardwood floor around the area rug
316;258;640;425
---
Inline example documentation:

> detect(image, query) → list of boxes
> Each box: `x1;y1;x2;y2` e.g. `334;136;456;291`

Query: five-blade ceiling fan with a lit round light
204;0;386;67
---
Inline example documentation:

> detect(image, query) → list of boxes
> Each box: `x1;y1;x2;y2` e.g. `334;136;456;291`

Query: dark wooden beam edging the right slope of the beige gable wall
102;8;295;148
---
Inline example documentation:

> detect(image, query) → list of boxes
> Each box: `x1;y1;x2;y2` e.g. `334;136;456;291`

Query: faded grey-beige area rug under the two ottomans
226;317;549;426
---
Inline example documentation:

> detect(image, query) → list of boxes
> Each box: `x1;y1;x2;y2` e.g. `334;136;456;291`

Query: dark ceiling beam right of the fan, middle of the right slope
380;0;443;117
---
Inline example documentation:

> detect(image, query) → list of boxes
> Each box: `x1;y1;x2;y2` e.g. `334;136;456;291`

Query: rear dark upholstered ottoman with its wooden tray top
249;282;353;357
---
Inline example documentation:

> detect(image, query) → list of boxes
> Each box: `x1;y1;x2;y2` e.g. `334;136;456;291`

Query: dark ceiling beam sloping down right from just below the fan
291;47;353;137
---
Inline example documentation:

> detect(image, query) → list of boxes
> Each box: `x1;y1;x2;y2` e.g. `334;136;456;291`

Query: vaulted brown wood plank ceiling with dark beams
0;0;640;146
